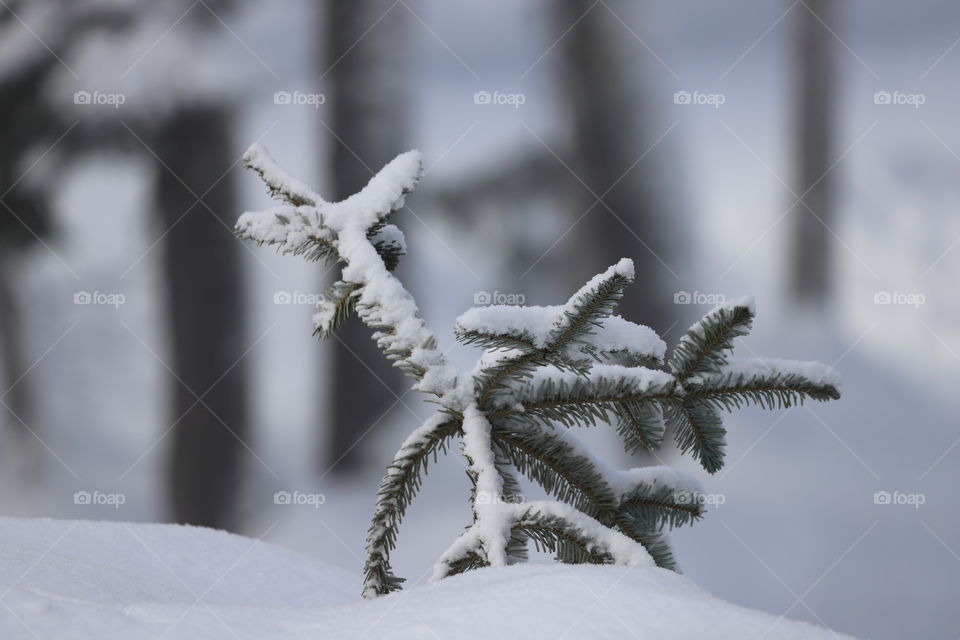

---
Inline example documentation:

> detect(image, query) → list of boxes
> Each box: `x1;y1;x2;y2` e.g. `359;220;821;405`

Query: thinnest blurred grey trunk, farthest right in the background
789;0;836;306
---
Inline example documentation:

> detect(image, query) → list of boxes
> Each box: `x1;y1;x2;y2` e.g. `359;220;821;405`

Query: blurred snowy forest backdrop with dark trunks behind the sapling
0;0;960;638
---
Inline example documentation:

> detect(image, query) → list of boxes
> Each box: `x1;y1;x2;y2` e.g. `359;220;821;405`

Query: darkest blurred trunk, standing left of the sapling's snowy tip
154;107;249;528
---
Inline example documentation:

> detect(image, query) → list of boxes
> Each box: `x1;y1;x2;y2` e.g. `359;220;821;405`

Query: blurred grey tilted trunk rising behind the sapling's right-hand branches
553;0;675;331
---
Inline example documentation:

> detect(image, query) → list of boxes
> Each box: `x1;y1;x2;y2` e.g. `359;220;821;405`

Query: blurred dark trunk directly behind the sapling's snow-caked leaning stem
320;0;407;474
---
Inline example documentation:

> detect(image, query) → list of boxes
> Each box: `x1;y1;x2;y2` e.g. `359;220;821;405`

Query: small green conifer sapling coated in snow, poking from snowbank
236;145;840;597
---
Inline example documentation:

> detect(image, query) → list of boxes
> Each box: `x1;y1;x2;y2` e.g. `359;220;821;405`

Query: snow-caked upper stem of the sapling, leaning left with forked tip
236;145;457;396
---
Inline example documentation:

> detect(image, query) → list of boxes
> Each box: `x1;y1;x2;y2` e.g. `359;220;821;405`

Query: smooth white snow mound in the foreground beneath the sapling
0;518;849;640
